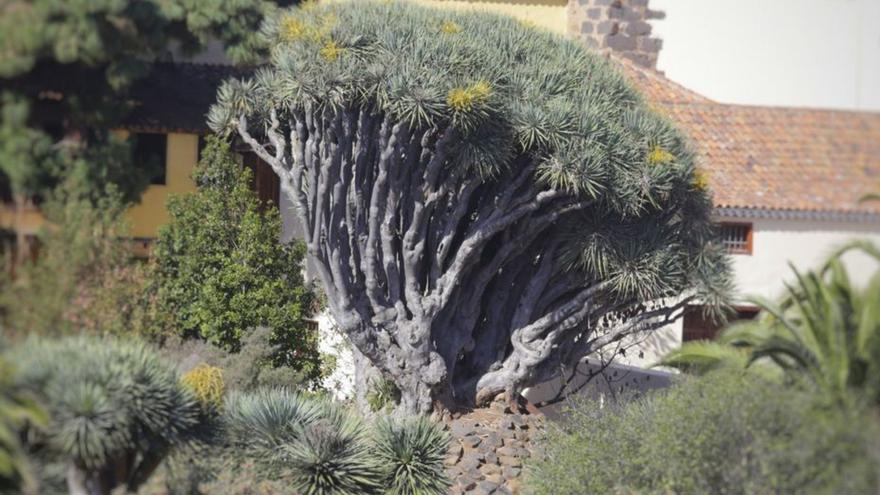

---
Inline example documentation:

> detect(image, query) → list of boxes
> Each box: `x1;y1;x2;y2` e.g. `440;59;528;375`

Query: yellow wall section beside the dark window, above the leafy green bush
128;133;199;238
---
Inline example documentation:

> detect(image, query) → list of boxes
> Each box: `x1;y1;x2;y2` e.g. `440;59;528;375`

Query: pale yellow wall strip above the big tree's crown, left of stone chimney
413;0;568;35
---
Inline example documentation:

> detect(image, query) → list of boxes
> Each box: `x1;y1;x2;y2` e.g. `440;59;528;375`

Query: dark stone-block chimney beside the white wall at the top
567;0;666;69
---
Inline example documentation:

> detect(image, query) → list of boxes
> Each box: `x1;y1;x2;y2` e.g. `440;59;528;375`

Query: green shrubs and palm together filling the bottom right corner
529;242;880;494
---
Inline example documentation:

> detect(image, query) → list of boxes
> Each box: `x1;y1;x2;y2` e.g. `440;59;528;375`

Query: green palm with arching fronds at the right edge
659;241;880;403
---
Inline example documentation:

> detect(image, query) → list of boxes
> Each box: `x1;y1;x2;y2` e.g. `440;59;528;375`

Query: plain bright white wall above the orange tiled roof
650;0;880;111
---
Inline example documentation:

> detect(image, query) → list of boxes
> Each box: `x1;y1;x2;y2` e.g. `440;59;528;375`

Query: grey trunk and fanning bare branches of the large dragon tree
238;107;684;413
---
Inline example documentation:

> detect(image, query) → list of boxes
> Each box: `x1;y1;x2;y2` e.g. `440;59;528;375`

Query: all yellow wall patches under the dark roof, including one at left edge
0;133;199;238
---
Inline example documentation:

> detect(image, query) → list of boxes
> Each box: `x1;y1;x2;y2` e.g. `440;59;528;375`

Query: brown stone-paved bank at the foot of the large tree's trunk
445;402;544;495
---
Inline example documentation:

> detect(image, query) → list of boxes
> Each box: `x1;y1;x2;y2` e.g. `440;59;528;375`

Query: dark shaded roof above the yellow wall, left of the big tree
124;62;247;134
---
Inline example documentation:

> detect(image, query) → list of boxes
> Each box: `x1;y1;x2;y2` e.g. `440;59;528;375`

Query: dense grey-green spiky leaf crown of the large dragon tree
209;1;729;308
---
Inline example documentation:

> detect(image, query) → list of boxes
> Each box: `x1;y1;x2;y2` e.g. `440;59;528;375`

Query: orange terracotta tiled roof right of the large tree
615;58;880;213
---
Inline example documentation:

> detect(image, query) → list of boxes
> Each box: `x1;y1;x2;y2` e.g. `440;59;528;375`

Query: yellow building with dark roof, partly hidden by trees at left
0;62;279;255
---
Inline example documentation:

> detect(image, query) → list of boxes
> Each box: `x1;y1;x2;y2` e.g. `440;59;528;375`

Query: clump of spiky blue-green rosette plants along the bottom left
2;337;450;495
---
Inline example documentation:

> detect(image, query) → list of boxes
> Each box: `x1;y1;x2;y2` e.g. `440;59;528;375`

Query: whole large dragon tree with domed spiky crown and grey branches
209;2;729;413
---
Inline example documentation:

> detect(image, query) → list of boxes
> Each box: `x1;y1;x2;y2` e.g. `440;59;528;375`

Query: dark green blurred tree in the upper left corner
0;0;274;246
